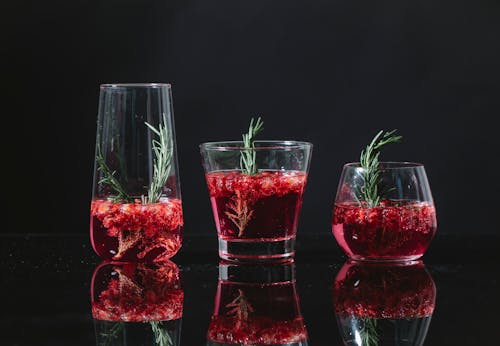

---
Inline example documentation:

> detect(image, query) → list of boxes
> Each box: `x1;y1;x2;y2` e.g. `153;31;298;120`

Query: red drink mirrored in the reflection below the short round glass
333;262;436;319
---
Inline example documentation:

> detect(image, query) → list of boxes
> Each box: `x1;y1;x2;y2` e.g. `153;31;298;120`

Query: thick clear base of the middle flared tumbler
219;237;295;262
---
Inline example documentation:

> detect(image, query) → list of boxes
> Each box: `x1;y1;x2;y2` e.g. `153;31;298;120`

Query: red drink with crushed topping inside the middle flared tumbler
206;171;307;241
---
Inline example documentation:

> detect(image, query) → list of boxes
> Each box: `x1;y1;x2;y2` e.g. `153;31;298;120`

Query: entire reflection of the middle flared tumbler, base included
207;262;307;346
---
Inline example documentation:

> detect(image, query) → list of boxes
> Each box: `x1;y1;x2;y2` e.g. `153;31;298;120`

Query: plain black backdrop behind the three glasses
4;0;500;235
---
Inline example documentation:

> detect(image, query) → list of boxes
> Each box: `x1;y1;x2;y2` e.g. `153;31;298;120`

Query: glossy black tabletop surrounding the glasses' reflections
0;236;500;346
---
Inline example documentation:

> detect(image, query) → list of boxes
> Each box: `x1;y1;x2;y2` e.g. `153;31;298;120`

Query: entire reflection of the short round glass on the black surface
333;261;436;346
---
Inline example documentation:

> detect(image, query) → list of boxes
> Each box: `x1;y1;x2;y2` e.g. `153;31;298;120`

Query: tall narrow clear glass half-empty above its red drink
90;84;183;262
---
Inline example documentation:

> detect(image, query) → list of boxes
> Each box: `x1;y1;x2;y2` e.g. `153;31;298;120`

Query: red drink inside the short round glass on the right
332;201;437;260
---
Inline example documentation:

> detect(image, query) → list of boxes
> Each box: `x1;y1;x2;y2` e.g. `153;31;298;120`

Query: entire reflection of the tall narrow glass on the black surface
91;261;184;346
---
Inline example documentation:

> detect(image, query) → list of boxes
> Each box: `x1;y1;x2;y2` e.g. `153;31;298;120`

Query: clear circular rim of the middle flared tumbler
200;140;313;151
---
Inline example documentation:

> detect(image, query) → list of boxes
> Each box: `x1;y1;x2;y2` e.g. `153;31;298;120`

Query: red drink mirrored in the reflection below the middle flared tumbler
207;281;307;345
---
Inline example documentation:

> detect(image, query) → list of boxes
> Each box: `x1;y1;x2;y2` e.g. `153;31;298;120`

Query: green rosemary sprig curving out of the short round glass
360;130;403;208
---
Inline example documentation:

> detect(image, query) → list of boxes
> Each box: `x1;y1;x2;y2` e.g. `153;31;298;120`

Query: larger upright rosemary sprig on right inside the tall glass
142;122;172;204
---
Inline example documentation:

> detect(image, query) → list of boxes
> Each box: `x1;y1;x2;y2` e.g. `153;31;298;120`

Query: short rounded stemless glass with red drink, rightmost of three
332;162;437;261
